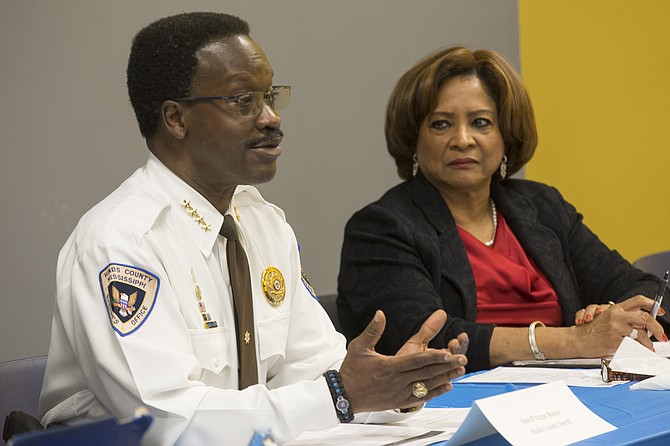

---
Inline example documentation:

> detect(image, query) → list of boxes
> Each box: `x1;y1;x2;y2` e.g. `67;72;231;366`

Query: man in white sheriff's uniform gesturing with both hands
40;13;467;445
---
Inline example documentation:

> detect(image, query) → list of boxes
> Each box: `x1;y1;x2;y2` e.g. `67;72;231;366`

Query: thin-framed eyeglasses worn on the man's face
172;85;291;117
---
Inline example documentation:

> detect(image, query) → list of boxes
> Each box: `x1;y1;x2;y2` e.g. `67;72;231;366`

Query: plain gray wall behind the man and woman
0;0;519;360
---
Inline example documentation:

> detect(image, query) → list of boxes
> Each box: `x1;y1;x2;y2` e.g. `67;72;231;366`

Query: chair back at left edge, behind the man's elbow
0;355;47;428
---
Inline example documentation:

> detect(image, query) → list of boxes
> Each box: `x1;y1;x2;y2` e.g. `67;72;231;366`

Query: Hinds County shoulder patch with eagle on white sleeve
100;263;160;336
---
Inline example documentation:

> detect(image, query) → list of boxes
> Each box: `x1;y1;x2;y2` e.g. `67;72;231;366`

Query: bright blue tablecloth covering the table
427;374;670;446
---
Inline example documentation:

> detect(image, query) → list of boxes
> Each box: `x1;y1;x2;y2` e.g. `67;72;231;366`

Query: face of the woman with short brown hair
416;76;505;197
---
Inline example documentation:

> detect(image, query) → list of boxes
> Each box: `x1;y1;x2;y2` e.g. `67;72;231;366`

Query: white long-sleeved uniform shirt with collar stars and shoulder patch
40;156;346;445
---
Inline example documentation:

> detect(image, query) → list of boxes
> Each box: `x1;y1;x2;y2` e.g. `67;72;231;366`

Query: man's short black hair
127;12;249;138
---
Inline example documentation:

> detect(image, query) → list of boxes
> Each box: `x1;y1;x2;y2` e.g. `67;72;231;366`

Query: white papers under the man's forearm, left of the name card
282;408;470;446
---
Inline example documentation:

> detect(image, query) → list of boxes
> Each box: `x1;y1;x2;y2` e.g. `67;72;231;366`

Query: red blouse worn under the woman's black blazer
458;213;563;326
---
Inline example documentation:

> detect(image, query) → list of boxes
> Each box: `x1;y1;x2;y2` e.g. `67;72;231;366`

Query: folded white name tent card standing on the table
449;381;616;446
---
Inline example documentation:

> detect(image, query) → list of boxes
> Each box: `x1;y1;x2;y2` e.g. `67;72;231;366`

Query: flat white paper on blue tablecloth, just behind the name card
456;367;624;387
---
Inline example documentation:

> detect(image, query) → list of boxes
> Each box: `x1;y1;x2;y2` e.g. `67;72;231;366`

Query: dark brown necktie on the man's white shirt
219;214;258;389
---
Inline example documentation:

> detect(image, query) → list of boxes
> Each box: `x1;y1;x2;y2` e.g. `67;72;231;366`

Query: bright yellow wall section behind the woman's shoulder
519;0;670;266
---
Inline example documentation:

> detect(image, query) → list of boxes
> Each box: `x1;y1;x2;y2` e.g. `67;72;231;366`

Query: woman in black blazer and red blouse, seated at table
338;47;668;371
